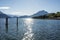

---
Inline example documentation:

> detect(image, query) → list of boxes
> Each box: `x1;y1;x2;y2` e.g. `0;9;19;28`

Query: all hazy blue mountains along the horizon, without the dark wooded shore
0;10;48;18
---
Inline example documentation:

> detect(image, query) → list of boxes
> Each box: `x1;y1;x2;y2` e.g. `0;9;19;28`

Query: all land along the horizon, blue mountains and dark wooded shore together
0;10;60;20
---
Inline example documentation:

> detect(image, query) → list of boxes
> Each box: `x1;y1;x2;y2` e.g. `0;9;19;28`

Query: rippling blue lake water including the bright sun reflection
0;18;60;40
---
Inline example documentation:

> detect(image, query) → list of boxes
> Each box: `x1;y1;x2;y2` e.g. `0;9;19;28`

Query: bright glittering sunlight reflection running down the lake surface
22;19;33;40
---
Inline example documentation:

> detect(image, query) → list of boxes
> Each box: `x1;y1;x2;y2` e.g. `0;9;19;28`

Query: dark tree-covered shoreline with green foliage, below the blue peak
32;12;60;20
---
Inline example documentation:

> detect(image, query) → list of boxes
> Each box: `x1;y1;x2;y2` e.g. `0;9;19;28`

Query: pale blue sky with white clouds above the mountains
0;0;60;16
